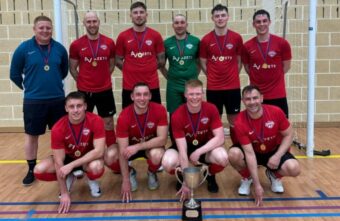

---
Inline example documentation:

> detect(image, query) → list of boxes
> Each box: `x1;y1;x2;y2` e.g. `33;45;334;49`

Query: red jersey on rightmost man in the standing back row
242;34;292;99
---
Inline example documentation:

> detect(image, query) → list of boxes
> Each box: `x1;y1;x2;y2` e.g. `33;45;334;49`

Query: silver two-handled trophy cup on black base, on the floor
175;165;208;221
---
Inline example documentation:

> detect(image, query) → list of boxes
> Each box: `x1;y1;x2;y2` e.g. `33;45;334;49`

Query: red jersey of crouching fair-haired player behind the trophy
171;102;222;144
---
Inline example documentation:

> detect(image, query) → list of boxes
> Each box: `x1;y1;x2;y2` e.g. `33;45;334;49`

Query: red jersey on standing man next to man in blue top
70;34;116;92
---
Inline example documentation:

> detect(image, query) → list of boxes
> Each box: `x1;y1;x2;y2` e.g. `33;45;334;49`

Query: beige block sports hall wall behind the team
0;0;340;131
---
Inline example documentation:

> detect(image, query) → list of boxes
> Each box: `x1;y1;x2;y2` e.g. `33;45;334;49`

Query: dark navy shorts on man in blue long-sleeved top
23;98;66;136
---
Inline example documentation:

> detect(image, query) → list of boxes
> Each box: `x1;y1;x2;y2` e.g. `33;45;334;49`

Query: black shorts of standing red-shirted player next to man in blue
80;89;116;117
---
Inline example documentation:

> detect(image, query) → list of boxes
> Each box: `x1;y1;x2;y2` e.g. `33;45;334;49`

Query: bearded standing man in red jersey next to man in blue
70;11;116;155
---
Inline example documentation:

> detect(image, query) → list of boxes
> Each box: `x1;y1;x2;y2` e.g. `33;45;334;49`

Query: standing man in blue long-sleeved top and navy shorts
10;15;68;186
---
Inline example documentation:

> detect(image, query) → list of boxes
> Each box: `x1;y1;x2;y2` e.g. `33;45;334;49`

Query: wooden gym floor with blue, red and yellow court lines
0;128;340;221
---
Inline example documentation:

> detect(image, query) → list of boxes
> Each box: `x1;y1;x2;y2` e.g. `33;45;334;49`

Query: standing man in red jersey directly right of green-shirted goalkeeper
200;4;243;142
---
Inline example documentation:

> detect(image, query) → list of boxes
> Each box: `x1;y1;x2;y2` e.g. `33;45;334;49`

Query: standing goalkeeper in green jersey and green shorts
160;14;200;148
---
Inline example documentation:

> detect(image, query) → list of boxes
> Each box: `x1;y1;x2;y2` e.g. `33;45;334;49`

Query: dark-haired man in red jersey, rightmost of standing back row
242;9;292;118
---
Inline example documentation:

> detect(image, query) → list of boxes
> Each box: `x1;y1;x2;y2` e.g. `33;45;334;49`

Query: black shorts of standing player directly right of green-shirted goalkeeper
207;89;241;115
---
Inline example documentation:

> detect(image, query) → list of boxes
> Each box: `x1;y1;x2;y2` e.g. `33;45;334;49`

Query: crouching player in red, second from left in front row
117;82;168;202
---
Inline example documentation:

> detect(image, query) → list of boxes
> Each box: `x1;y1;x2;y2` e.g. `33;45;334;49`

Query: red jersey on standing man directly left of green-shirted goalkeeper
116;28;165;90
